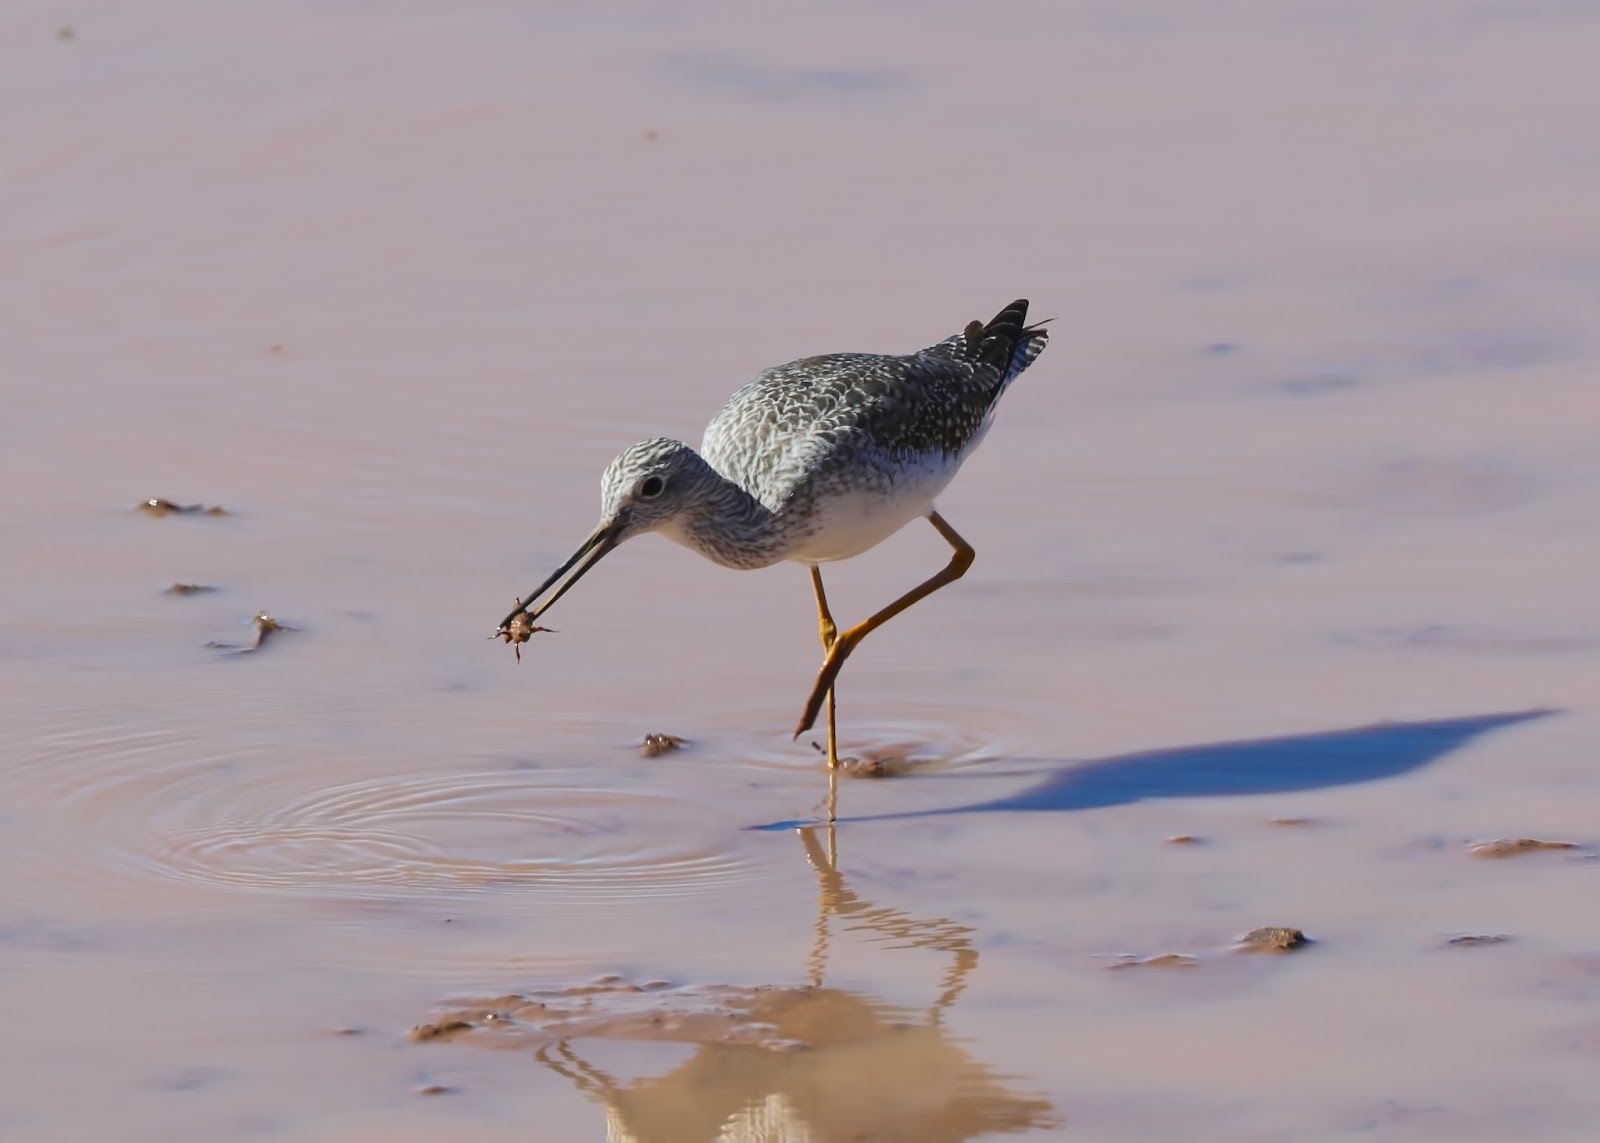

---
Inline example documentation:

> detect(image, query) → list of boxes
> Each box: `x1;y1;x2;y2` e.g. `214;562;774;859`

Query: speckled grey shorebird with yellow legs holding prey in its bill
496;299;1048;818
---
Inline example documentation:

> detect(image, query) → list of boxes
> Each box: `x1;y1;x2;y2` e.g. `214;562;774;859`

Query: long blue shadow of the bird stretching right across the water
752;711;1555;829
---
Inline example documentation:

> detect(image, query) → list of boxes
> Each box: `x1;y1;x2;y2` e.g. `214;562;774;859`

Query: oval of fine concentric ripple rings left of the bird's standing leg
130;772;742;901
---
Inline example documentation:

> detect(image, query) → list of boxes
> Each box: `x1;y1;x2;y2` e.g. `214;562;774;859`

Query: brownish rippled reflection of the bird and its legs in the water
538;826;1056;1143
